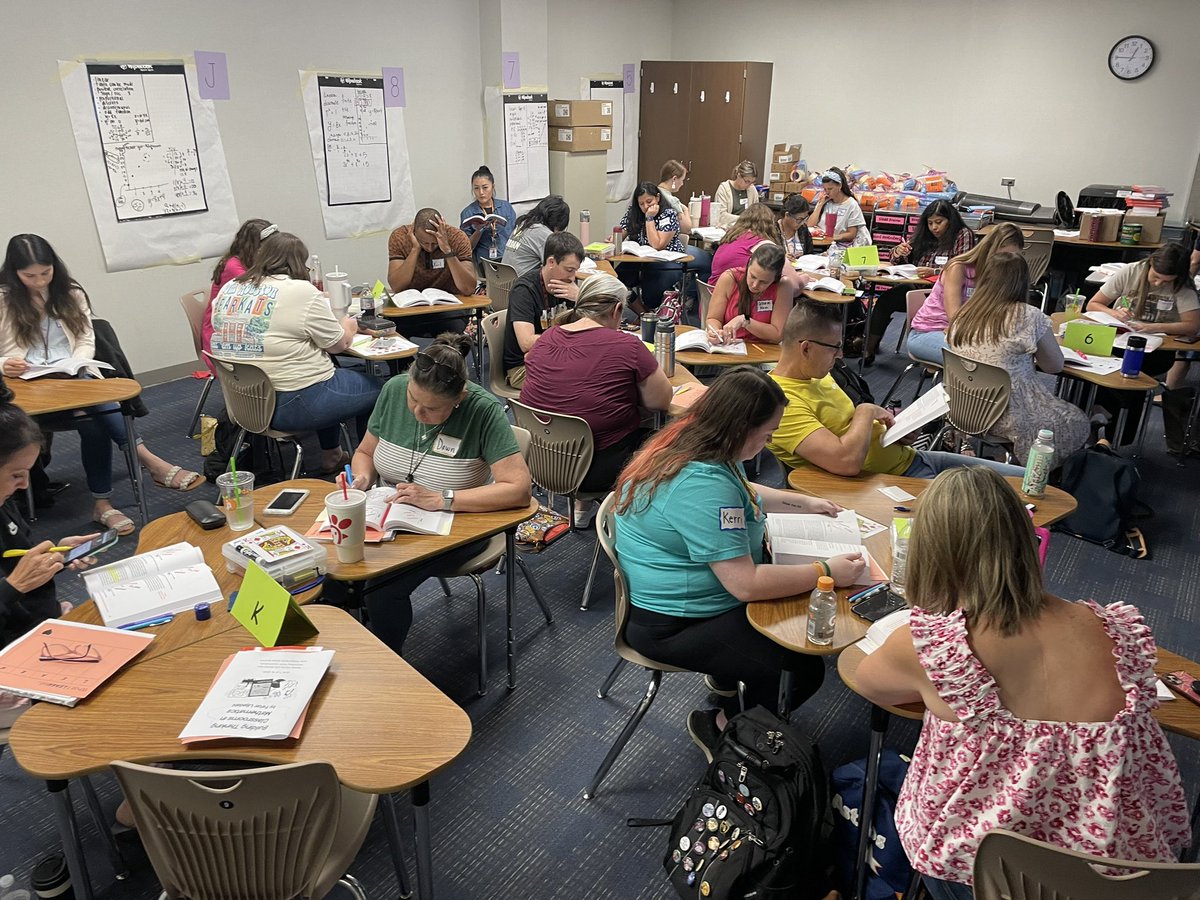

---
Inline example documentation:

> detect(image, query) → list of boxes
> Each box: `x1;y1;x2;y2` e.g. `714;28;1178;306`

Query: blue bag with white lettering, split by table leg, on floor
830;750;912;900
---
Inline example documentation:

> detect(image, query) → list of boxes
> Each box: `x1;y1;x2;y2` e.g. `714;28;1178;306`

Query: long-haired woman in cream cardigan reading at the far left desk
0;234;204;535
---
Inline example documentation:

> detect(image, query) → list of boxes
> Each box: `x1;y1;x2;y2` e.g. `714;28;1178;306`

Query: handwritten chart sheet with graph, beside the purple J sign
88;64;208;222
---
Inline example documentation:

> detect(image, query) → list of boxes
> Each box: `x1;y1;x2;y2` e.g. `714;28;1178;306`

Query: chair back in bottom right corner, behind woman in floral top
973;828;1200;900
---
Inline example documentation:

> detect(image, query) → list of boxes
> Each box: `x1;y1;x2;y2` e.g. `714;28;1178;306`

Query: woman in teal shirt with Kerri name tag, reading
616;366;864;758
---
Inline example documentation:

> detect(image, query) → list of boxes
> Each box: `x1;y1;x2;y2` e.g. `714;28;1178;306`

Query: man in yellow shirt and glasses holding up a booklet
767;300;1022;478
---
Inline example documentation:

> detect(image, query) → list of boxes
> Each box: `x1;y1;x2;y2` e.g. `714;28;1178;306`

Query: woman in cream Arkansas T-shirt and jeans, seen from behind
211;232;379;475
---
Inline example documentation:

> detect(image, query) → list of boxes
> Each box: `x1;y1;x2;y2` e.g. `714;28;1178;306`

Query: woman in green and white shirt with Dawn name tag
350;334;540;653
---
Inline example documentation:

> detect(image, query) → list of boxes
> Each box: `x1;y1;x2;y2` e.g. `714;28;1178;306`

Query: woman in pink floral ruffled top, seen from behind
858;467;1189;900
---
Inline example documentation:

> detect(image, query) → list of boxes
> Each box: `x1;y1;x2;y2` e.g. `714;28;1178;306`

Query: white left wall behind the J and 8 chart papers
0;0;487;372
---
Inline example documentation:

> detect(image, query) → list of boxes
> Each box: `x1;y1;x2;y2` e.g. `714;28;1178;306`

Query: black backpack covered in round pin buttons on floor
662;707;832;900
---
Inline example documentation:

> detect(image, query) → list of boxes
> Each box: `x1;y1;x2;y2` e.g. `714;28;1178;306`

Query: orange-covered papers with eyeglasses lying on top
0;619;154;707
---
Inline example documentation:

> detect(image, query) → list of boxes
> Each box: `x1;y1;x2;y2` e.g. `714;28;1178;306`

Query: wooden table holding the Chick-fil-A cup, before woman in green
265;479;547;688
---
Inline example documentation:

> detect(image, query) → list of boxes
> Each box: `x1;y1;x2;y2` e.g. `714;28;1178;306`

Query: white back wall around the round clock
671;0;1200;223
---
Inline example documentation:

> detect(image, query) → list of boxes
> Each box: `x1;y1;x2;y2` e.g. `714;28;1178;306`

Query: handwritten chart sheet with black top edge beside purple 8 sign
317;76;391;206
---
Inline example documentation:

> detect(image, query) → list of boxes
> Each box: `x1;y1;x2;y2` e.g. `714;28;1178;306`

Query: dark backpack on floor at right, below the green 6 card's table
1055;440;1150;559
